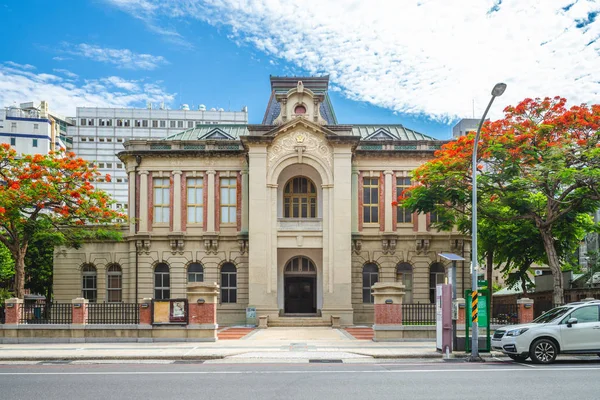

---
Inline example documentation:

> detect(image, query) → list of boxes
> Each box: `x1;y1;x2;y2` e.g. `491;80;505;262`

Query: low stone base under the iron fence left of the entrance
0;324;218;343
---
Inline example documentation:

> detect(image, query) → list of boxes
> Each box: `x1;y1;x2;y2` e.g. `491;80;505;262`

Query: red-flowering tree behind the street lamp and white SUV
398;97;600;303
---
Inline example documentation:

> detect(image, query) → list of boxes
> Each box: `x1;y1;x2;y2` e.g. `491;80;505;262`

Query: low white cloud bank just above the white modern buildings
0;65;175;116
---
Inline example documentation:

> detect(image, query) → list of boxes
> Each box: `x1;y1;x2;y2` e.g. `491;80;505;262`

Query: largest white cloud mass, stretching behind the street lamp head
106;0;600;121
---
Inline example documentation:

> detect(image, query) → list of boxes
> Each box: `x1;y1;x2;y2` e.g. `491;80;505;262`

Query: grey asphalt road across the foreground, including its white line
0;359;600;400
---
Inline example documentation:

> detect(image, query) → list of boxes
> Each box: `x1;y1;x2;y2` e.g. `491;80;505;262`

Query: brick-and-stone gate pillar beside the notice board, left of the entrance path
187;282;219;342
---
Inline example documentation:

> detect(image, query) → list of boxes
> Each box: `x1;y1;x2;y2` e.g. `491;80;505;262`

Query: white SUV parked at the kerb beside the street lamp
492;300;600;364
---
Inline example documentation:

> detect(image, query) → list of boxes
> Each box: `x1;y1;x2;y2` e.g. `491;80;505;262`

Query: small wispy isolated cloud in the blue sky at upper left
61;43;169;70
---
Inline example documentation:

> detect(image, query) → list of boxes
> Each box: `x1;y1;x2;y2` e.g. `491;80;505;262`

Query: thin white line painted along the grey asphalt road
0;367;600;376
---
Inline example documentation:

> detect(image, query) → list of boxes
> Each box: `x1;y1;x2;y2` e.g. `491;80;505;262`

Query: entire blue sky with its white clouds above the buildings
0;0;600;139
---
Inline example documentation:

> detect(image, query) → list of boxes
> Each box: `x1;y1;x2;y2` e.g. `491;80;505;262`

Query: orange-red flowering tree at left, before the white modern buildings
0;144;125;298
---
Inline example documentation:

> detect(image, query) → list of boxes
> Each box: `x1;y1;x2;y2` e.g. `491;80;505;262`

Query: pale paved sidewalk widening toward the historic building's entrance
0;328;502;362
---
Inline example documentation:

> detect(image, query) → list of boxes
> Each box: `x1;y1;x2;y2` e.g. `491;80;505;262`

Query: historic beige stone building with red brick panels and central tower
54;77;470;325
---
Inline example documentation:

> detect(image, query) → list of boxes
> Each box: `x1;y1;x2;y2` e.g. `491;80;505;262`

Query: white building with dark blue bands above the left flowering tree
0;101;72;154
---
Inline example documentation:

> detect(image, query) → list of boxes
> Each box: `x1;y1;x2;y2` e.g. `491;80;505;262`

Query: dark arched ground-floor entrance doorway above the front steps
283;256;317;314
